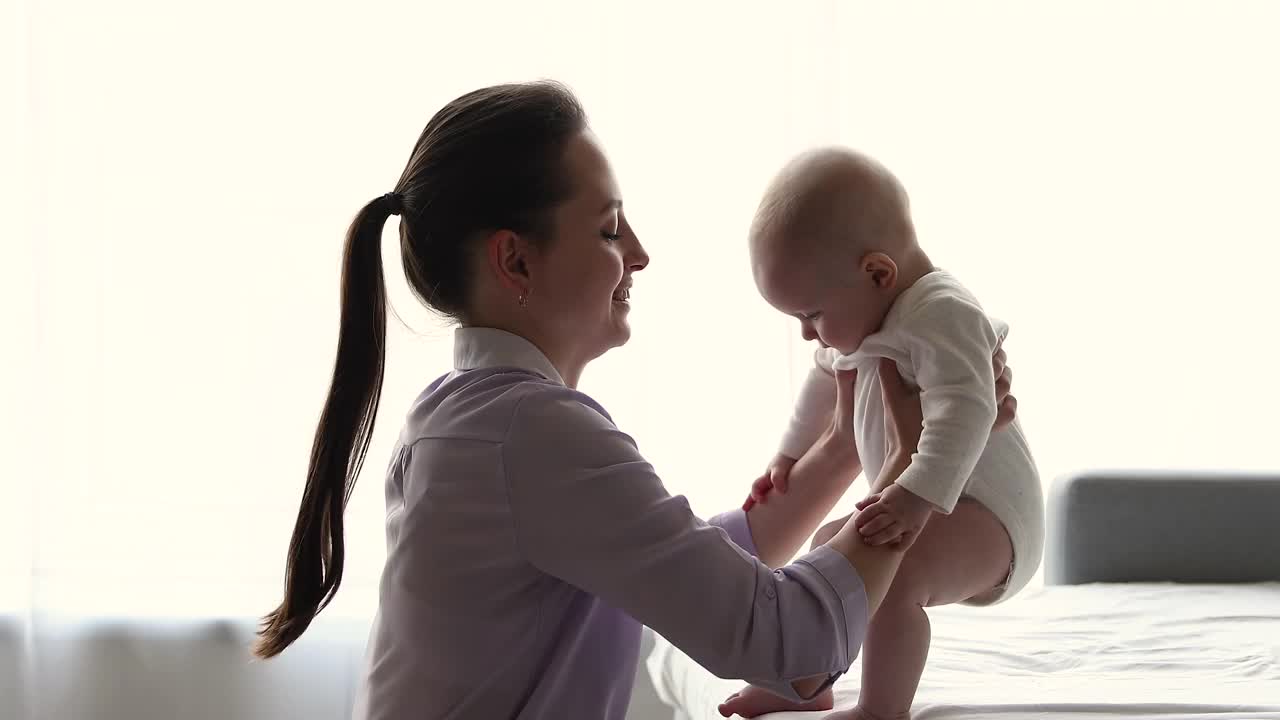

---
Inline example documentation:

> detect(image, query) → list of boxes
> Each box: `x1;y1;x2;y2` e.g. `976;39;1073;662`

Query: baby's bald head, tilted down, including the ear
750;149;929;354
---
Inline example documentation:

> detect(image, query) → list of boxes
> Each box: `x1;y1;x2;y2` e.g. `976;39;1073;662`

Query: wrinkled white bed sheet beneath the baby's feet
648;583;1280;720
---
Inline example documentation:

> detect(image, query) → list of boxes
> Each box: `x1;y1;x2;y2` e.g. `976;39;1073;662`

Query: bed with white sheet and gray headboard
646;473;1280;720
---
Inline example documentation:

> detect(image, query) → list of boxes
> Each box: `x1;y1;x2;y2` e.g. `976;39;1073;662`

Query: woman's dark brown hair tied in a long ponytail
253;82;586;657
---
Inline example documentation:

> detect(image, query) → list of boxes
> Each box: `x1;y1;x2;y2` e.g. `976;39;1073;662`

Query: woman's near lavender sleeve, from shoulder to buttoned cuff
503;388;868;701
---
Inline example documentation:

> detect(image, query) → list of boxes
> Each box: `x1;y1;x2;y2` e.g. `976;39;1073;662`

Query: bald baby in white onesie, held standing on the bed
721;149;1044;720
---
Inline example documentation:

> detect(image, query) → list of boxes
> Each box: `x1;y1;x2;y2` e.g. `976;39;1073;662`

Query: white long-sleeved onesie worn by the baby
781;270;1044;605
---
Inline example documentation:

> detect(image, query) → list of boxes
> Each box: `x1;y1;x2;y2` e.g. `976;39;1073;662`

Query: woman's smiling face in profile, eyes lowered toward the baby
526;131;649;371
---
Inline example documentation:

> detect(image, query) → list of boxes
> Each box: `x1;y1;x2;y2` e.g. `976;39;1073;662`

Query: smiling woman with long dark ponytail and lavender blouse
256;83;1018;719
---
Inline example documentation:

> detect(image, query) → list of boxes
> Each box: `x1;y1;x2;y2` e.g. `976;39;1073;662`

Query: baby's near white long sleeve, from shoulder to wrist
897;297;1000;514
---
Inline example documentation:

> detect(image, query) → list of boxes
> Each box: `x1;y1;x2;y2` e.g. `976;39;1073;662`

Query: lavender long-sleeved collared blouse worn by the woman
355;328;867;720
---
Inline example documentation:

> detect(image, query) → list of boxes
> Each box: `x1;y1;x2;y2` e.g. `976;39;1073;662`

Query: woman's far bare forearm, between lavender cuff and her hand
746;433;861;568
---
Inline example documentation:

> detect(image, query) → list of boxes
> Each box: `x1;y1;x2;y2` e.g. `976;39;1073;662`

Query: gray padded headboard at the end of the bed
1044;470;1280;585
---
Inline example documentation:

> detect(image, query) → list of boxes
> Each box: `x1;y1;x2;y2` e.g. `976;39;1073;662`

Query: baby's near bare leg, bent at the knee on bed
837;498;1014;720
